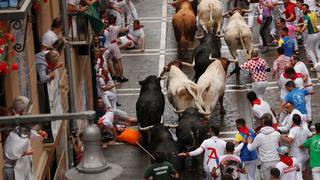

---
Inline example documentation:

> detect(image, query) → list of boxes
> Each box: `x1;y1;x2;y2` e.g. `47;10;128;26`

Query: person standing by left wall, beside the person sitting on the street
104;16;128;83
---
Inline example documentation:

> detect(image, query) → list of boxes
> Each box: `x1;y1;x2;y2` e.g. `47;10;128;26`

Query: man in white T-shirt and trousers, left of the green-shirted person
281;114;312;178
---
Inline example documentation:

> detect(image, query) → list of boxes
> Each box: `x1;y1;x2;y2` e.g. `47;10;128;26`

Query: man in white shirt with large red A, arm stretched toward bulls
178;126;227;180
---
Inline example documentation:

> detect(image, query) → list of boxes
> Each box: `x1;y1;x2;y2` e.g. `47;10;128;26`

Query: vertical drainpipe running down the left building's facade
59;0;77;166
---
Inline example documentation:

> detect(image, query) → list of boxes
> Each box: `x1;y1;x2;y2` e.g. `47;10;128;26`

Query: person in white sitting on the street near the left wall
119;20;145;52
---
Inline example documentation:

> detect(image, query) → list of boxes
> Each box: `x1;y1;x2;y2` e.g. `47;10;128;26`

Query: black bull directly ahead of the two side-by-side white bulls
192;32;221;82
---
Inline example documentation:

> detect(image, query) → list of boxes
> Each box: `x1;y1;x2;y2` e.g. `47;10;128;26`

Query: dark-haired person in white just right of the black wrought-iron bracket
41;16;63;49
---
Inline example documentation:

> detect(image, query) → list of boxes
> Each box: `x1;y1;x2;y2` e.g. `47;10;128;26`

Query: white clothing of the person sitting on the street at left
119;26;145;48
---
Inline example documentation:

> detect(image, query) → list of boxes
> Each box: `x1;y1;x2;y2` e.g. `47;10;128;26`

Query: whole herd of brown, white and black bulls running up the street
136;0;253;174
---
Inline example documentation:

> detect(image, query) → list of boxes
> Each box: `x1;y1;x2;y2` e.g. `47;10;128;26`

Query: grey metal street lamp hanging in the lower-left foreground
65;124;122;180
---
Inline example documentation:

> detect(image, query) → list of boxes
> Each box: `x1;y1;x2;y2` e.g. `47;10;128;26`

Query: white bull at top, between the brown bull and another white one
198;0;223;34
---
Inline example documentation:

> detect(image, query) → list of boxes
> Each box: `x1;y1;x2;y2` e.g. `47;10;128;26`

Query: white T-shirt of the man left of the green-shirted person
288;126;312;158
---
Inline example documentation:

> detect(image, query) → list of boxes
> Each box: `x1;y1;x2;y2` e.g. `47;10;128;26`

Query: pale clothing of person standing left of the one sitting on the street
104;25;121;59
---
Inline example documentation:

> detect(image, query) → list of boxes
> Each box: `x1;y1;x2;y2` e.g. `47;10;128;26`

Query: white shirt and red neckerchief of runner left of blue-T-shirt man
252;99;277;128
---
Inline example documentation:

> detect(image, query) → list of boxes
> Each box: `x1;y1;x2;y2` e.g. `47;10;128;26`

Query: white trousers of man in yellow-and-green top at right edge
306;33;320;65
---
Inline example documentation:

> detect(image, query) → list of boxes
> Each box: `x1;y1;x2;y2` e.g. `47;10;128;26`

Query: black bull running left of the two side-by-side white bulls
136;75;165;145
